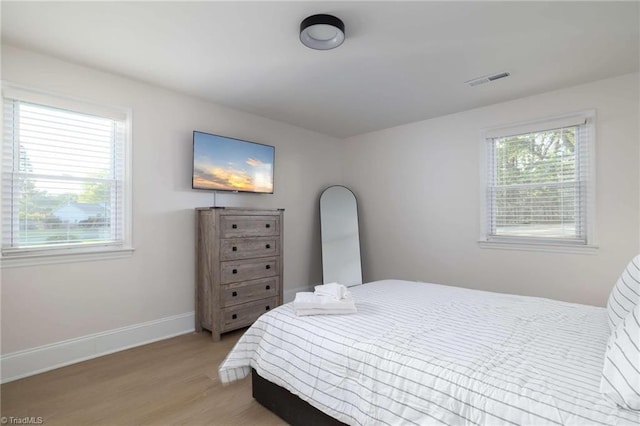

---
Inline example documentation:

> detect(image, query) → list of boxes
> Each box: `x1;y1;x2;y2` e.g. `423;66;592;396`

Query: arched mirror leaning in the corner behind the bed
320;185;362;287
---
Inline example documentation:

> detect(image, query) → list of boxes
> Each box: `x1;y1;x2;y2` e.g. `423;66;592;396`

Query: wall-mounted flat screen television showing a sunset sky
191;131;275;194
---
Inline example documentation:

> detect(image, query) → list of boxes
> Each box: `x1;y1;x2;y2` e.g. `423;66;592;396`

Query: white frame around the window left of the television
0;81;133;268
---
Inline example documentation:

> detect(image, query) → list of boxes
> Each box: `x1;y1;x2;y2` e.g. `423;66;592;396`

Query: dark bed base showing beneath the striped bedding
251;368;345;426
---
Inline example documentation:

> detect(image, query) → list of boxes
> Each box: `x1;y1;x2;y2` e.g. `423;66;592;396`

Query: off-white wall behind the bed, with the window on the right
345;74;640;306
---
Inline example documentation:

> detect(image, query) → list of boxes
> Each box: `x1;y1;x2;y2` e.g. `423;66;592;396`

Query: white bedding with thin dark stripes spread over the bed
219;280;640;425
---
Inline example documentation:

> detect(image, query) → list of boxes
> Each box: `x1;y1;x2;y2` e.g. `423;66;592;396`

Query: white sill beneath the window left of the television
0;247;134;268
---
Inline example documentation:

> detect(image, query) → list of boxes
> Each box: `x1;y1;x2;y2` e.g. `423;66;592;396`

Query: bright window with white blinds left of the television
2;86;131;263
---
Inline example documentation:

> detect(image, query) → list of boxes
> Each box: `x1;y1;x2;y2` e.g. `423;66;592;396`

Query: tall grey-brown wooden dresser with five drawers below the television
196;207;284;341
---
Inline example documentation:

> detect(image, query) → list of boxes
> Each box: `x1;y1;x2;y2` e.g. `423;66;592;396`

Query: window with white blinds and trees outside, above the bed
482;113;595;251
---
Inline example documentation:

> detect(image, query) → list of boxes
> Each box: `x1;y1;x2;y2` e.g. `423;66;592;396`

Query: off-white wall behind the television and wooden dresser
2;46;342;365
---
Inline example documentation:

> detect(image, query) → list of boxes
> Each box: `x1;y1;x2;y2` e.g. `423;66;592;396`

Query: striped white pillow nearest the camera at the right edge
600;305;640;410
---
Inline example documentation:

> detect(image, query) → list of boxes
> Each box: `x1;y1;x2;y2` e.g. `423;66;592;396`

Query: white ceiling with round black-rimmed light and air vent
2;1;640;138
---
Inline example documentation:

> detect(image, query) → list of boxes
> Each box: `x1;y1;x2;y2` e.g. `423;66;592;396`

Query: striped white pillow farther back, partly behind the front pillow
607;255;640;332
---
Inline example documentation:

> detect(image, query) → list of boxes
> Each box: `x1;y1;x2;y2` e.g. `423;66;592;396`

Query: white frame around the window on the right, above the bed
478;110;598;254
